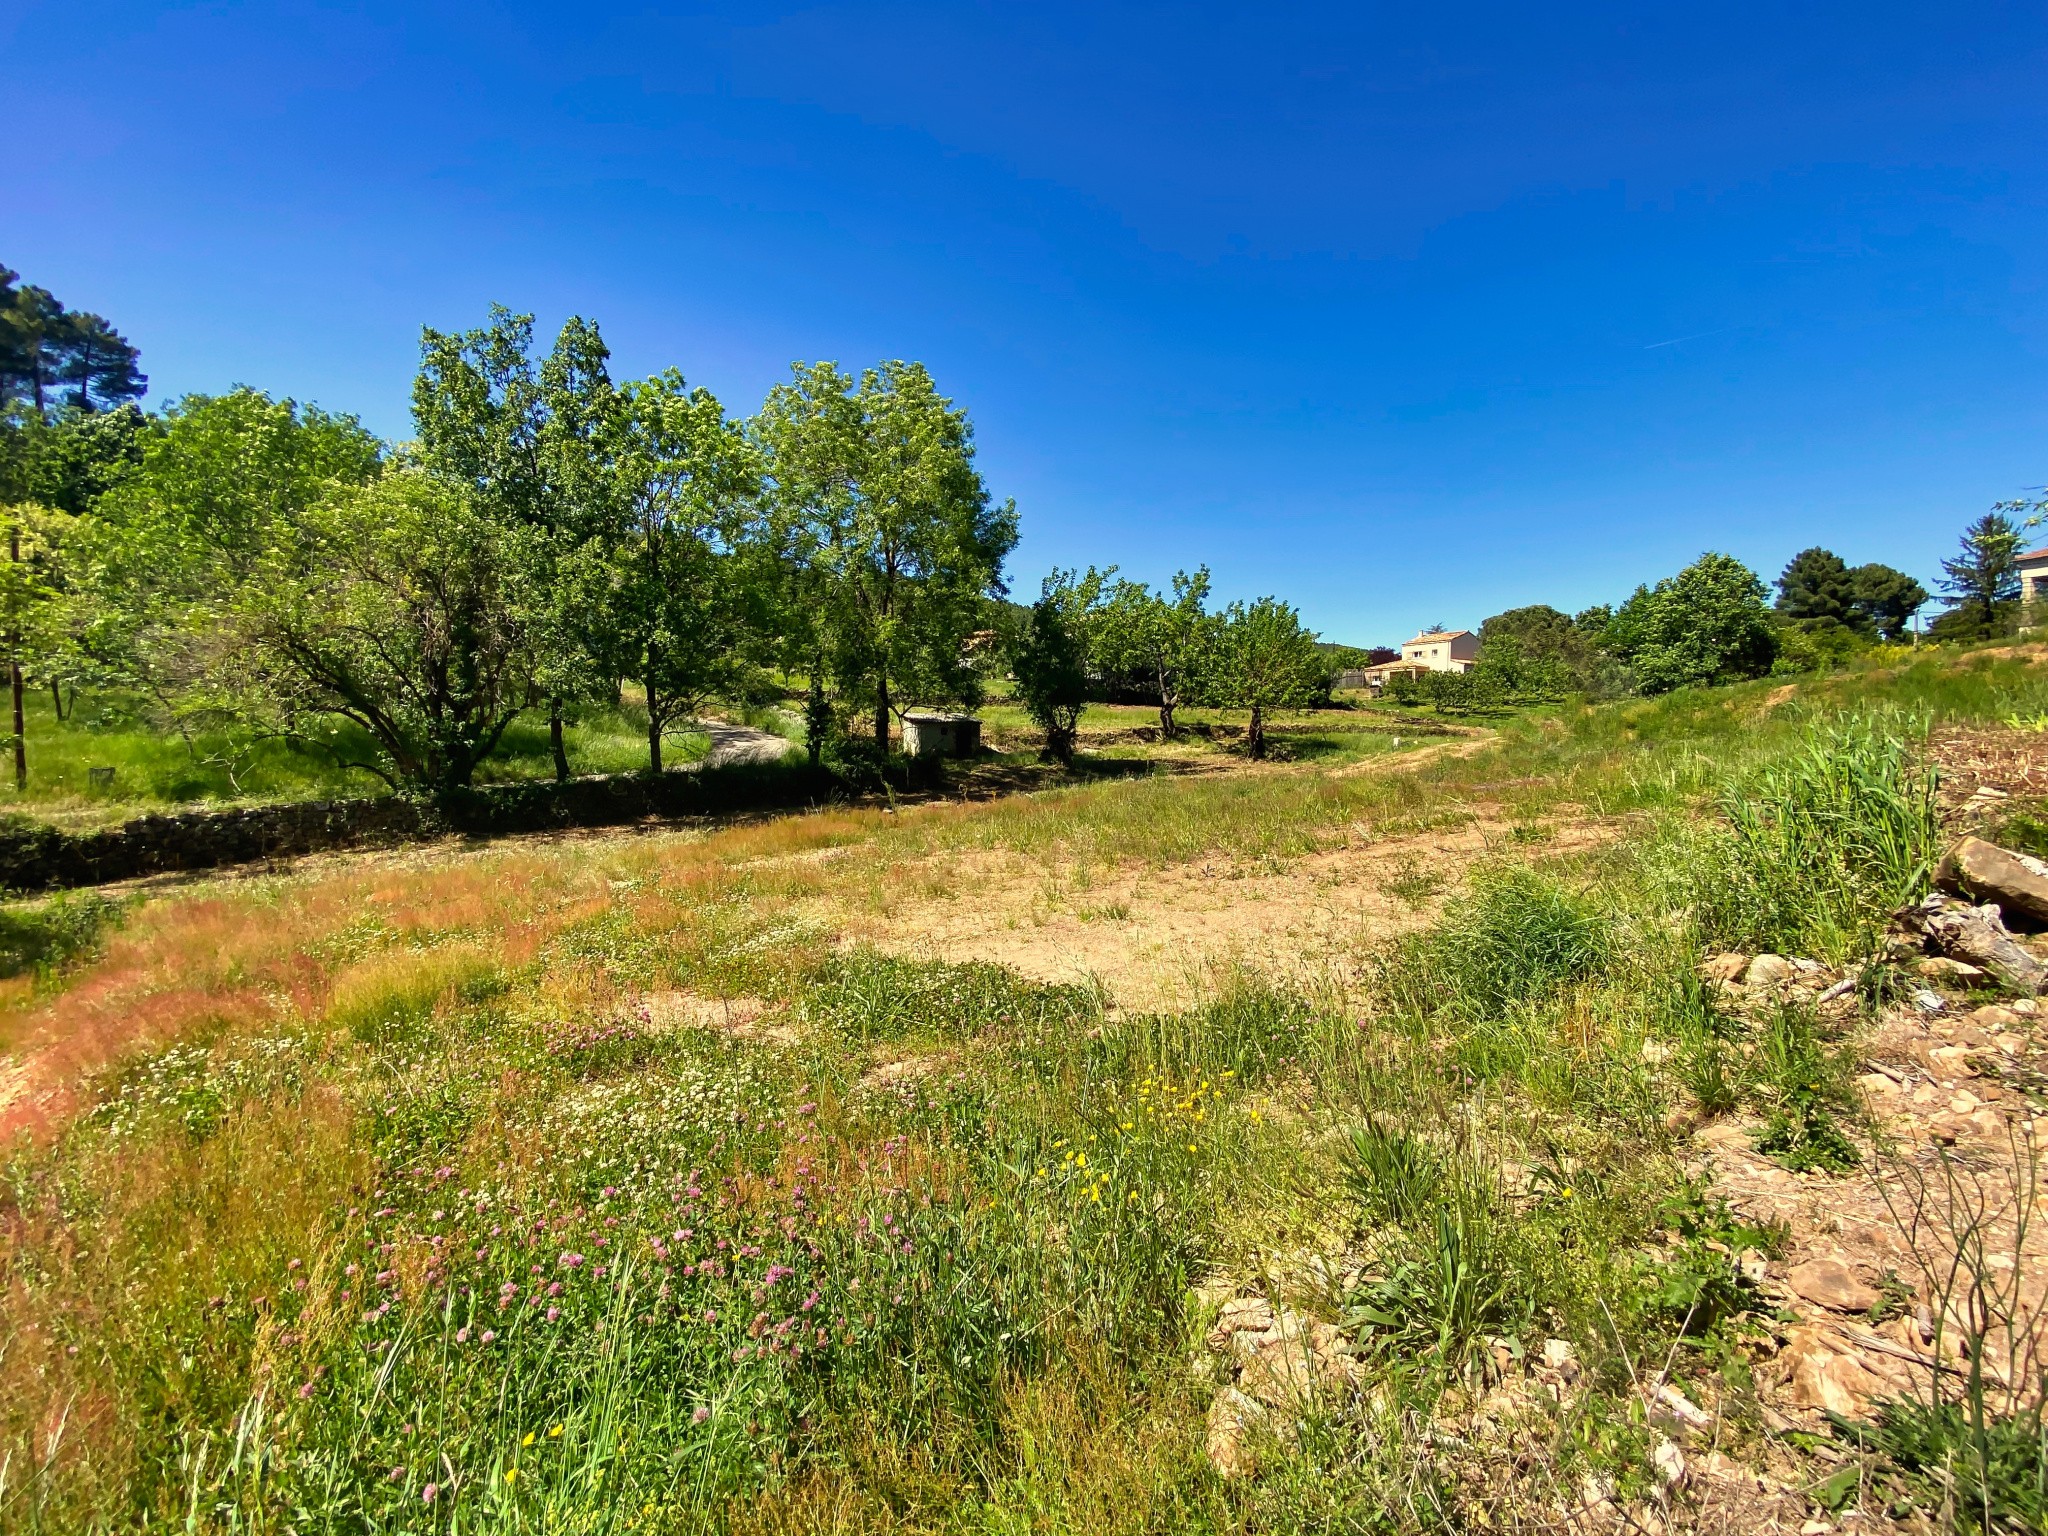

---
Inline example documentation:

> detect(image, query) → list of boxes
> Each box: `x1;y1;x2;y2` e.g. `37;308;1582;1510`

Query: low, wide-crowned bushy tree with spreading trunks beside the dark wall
230;469;532;801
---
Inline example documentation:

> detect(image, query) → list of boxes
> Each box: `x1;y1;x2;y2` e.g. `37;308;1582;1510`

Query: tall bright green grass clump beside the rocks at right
1696;711;1939;958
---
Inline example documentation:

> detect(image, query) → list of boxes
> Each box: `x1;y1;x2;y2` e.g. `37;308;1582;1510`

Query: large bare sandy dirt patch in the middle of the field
838;821;1622;1010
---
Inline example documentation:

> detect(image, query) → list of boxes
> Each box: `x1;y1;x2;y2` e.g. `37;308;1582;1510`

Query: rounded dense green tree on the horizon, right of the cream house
1608;553;1778;694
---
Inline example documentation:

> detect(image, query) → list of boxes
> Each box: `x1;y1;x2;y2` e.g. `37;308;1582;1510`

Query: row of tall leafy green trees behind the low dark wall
0;309;1016;797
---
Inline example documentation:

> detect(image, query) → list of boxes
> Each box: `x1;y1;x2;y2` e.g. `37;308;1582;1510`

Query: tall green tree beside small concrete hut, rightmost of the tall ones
756;362;1018;750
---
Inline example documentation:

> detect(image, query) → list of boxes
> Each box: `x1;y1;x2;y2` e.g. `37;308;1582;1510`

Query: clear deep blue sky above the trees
0;0;2048;643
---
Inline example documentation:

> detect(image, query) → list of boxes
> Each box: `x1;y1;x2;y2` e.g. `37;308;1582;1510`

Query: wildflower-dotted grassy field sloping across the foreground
0;653;2048;1532
